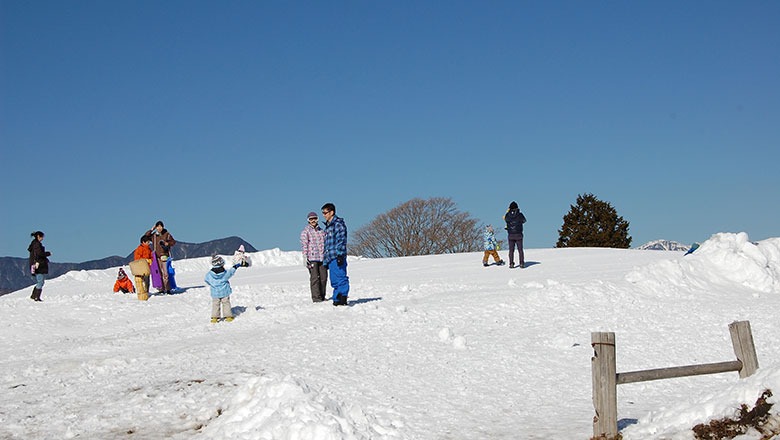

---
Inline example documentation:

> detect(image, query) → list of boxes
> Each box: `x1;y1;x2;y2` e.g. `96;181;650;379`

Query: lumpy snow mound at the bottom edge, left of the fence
203;376;400;440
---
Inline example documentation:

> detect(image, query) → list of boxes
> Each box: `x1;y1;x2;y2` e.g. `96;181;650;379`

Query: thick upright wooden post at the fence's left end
590;332;618;440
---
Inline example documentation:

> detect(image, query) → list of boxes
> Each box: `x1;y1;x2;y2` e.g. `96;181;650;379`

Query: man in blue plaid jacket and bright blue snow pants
322;203;349;306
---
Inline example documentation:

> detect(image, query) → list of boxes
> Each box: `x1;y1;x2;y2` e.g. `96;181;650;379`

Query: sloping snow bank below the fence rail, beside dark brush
622;365;780;440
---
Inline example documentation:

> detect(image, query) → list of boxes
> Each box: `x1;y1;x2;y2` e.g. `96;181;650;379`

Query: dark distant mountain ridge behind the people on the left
0;237;257;295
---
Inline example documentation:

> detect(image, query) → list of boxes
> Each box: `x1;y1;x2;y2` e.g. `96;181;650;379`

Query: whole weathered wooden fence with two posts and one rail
591;321;758;440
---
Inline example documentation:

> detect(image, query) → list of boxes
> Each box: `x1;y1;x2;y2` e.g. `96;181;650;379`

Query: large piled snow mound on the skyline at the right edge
626;232;780;293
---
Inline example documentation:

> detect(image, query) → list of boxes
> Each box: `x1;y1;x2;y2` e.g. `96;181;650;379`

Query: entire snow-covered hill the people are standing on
0;234;780;440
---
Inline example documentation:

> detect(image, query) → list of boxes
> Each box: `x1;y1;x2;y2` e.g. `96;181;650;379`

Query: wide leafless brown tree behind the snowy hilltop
350;197;482;258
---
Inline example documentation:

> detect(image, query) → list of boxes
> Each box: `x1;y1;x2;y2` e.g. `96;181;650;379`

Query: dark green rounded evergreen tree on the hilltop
555;194;631;248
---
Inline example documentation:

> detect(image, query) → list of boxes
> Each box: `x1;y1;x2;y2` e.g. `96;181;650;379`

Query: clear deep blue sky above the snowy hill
0;0;780;262
